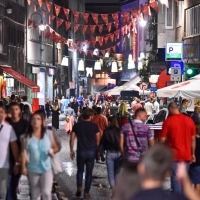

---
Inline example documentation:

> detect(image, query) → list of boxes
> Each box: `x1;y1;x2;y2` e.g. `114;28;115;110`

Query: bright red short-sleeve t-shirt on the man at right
160;114;196;161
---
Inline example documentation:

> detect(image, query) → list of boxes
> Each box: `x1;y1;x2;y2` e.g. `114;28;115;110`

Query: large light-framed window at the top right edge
185;4;200;37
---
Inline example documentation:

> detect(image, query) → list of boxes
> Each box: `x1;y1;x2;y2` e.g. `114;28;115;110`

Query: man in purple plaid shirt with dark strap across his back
120;108;154;169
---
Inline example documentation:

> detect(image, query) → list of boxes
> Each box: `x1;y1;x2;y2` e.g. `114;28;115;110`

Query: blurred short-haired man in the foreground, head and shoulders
131;145;187;200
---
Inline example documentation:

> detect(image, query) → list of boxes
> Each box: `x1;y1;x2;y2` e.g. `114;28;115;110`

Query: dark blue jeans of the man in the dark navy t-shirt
76;151;96;193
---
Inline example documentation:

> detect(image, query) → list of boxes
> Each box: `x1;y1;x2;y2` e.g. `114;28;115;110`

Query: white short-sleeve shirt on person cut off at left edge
0;123;17;169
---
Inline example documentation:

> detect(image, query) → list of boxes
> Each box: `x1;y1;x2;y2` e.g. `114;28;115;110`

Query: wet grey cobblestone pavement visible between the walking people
56;122;111;200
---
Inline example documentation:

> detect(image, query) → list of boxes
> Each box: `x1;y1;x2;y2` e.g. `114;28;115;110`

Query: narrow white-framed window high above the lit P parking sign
165;0;174;29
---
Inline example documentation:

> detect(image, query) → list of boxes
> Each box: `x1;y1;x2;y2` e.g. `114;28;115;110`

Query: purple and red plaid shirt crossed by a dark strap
120;120;153;162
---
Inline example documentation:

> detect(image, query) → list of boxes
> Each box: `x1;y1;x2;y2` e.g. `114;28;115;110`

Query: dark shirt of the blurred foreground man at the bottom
131;188;187;200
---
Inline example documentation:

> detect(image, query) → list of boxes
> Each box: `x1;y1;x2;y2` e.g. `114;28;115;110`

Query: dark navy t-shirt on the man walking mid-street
72;121;99;151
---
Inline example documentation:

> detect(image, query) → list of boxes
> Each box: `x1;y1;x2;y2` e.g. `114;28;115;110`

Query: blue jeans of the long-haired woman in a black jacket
106;152;121;188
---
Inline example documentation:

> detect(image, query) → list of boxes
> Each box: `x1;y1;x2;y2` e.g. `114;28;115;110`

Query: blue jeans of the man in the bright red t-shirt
171;162;190;193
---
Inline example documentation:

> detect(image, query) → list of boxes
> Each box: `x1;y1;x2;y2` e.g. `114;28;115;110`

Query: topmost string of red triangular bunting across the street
27;0;173;30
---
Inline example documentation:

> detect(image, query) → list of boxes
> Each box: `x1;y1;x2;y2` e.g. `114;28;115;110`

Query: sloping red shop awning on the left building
0;66;40;92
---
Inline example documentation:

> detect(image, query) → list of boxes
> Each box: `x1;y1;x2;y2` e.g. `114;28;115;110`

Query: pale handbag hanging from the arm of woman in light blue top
47;130;63;175
